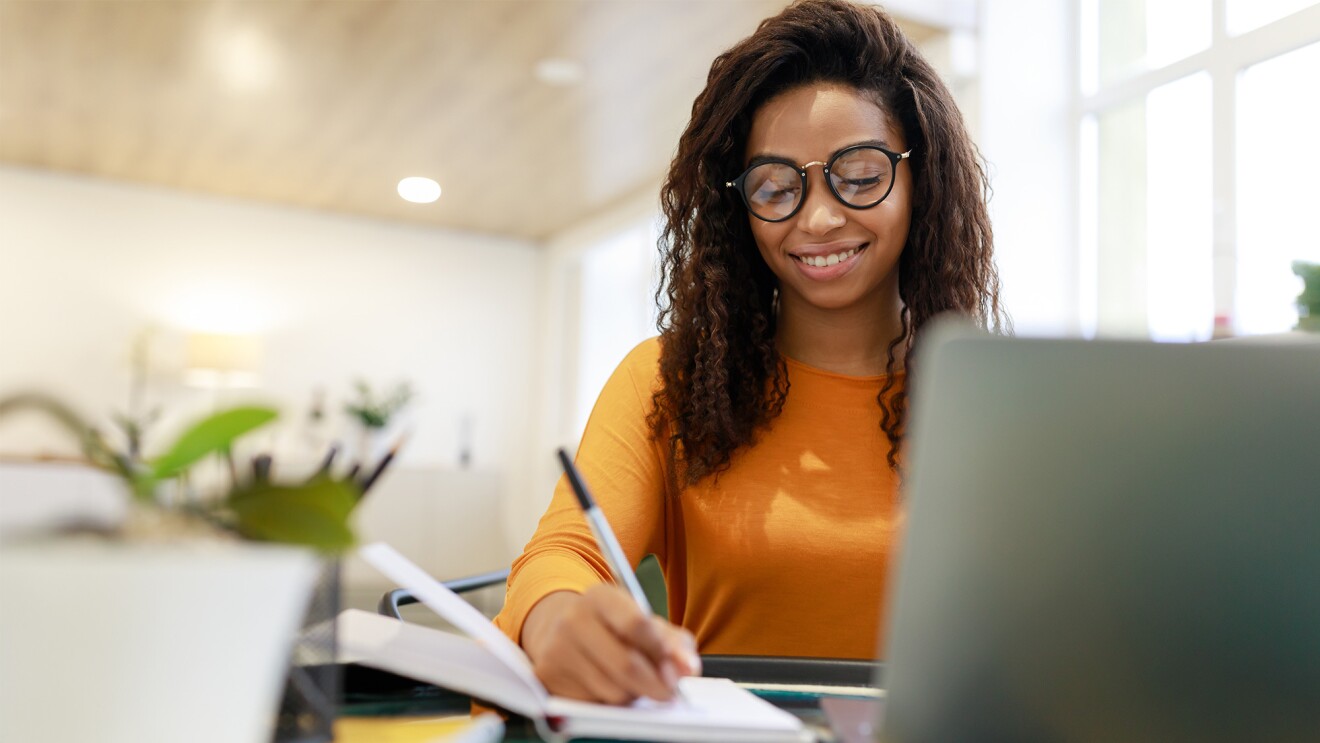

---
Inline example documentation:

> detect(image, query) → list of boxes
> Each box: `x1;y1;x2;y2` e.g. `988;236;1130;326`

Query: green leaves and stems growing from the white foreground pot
0;393;359;552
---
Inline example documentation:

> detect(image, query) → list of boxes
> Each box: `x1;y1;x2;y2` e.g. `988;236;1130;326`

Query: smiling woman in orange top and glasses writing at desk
496;0;1002;703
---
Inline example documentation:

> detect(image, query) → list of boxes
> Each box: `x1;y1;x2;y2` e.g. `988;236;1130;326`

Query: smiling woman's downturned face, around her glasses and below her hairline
744;83;912;319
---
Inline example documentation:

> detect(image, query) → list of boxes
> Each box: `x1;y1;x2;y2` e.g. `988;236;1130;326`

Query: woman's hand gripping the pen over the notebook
523;583;701;705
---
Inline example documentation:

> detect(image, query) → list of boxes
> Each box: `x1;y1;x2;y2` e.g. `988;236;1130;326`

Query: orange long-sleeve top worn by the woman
495;339;900;659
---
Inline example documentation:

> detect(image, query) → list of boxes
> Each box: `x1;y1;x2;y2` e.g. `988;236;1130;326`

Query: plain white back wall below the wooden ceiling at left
0;168;540;583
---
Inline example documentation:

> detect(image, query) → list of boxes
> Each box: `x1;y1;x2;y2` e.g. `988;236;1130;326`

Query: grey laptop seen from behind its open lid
843;327;1320;743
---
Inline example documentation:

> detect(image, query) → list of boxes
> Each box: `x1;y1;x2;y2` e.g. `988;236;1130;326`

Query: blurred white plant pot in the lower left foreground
0;544;317;743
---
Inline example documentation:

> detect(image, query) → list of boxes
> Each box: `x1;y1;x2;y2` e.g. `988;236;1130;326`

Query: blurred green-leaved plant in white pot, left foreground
0;393;359;743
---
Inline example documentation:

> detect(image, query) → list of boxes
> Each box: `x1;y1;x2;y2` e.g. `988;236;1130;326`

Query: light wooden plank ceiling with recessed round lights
0;0;935;239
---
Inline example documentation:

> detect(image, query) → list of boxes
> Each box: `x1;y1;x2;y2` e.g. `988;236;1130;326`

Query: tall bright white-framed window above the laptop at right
1078;0;1320;340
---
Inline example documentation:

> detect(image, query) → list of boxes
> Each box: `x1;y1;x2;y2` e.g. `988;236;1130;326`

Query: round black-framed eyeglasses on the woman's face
725;144;912;222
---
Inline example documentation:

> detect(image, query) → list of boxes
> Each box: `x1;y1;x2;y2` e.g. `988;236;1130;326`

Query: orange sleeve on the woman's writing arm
495;339;668;643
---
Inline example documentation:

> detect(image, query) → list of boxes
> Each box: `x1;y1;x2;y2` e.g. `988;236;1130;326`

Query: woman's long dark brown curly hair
648;0;1007;484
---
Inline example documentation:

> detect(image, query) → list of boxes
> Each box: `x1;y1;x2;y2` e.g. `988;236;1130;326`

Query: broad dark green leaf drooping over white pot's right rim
228;478;358;550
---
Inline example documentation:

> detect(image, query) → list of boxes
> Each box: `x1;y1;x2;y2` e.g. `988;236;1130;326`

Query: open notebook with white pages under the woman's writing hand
338;544;810;743
